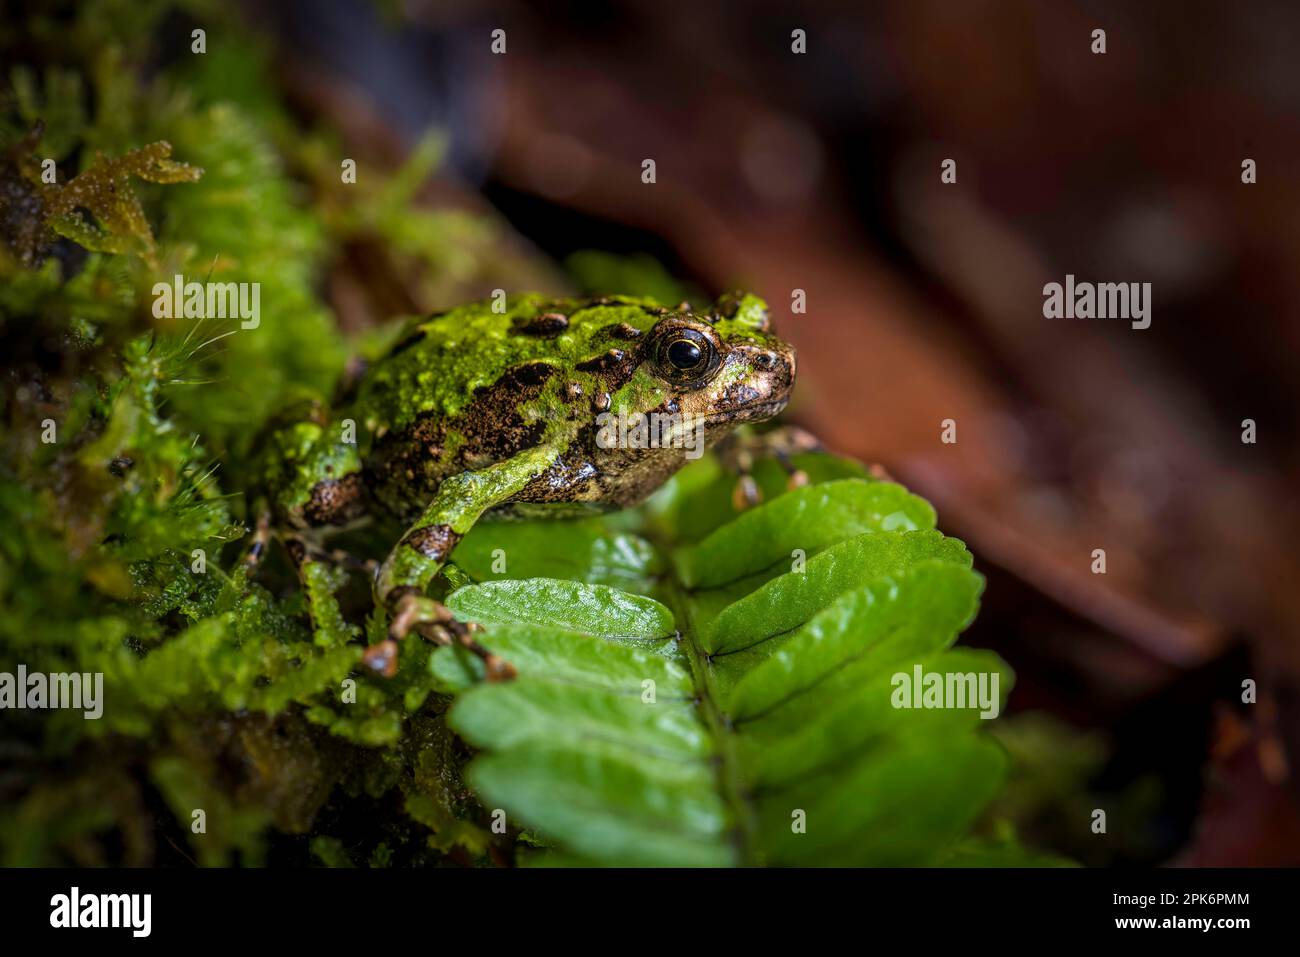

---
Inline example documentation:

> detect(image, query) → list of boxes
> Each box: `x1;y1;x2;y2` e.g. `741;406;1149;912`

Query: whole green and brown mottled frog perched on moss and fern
244;293;796;680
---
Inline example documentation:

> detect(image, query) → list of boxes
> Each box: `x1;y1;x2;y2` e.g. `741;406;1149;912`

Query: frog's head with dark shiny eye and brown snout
642;294;794;429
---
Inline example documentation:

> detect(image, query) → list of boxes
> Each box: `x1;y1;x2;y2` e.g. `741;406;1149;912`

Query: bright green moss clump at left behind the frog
0;1;525;866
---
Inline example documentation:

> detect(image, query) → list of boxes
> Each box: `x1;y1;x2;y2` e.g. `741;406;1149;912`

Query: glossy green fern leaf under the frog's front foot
430;456;1034;866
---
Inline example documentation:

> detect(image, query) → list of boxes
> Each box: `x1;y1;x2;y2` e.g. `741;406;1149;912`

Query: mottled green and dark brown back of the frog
352;294;667;514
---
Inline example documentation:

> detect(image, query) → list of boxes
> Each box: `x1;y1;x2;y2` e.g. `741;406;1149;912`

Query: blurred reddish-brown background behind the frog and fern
250;0;1300;865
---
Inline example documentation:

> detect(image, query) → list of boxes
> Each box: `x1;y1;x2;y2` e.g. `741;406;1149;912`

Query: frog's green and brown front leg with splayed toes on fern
365;446;558;680
